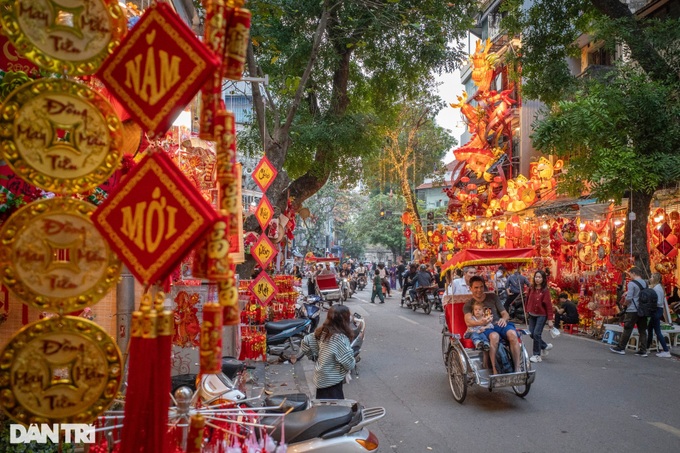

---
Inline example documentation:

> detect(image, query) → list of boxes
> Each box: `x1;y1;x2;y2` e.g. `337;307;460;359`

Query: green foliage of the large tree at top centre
239;0;476;187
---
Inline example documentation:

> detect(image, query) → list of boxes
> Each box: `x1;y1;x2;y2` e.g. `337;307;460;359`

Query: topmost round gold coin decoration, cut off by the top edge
0;0;127;76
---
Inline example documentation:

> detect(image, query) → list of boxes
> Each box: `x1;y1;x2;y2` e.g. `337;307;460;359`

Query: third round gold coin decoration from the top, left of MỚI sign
0;198;121;314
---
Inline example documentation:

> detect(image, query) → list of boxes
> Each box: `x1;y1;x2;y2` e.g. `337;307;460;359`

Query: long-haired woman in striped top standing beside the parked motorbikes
301;305;356;400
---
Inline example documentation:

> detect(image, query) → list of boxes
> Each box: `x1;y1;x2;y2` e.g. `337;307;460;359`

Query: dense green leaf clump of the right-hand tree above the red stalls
532;11;680;200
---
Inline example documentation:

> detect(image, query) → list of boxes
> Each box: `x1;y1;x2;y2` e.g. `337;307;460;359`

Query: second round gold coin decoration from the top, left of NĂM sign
0;79;122;193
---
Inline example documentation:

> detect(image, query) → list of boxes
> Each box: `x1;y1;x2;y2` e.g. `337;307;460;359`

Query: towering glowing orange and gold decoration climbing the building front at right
445;40;563;221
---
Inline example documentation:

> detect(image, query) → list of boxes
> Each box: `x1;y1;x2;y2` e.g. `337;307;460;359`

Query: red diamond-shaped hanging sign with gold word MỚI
93;151;217;284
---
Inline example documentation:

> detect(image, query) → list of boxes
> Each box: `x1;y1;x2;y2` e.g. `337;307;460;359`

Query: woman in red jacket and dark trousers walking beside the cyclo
527;271;554;363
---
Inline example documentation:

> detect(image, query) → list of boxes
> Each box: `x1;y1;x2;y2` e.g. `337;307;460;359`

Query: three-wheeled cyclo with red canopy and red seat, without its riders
440;248;536;403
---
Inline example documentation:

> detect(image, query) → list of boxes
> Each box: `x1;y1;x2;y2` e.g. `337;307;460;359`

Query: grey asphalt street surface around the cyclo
336;289;680;453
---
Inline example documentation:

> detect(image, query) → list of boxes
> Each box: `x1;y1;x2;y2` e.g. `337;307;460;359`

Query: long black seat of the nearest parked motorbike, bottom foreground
262;406;354;444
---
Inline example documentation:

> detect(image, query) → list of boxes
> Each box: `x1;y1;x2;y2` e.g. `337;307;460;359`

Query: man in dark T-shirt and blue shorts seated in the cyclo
463;275;521;374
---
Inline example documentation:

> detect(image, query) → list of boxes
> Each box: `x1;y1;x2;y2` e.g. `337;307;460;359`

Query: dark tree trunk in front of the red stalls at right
623;191;654;277
